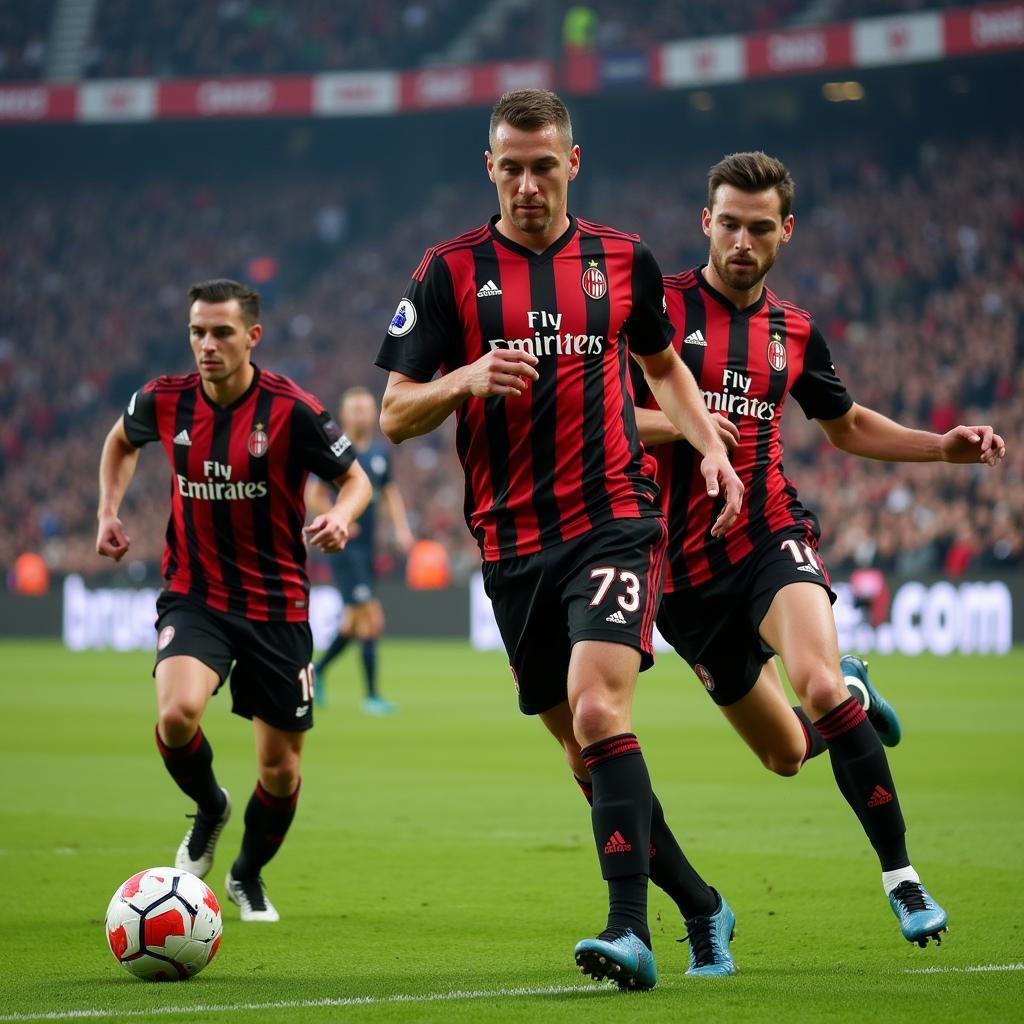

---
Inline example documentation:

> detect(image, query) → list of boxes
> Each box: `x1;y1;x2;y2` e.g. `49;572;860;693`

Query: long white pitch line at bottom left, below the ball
0;985;615;1024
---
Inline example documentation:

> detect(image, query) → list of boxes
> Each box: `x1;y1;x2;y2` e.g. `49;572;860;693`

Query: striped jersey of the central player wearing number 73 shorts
377;217;672;561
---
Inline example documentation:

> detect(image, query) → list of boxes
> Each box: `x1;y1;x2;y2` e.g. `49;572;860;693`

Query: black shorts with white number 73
483;516;666;715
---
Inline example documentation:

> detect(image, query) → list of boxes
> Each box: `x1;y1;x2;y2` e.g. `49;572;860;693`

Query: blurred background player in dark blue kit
310;387;414;715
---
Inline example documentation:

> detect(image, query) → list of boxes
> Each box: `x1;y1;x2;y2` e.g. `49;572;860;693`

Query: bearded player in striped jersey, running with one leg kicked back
634;153;1006;946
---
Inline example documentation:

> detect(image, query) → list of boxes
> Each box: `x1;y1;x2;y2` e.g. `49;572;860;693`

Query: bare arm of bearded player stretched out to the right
818;403;1007;466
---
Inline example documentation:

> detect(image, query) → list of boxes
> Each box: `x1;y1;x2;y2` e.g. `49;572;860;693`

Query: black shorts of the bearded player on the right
657;526;836;707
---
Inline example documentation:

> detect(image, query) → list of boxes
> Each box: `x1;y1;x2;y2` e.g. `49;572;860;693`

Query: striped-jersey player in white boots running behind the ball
96;280;371;922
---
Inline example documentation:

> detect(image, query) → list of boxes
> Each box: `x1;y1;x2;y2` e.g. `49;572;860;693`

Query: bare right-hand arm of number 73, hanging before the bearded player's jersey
635;347;743;537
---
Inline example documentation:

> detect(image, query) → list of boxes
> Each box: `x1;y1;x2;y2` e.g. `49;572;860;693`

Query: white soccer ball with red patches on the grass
104;867;224;981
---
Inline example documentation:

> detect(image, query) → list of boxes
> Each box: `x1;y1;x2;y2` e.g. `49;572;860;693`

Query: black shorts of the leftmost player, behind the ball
154;590;313;732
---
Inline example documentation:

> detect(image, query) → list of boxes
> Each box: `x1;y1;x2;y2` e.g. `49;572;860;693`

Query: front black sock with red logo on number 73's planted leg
582;732;651;946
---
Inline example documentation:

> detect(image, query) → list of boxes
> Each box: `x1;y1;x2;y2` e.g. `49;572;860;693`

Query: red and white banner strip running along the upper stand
0;2;1024;124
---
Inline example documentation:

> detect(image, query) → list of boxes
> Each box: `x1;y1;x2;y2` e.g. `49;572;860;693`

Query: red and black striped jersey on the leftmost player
123;368;354;622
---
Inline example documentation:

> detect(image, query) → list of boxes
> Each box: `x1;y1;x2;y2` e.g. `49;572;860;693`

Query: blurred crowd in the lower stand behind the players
0;134;1024;580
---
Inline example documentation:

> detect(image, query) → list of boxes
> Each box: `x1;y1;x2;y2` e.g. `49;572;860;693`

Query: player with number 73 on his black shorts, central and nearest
377;89;742;988
